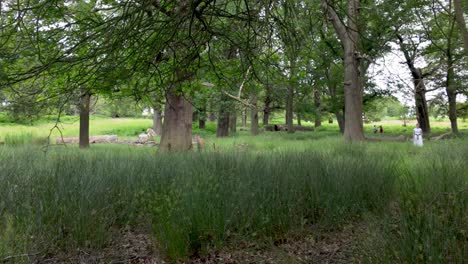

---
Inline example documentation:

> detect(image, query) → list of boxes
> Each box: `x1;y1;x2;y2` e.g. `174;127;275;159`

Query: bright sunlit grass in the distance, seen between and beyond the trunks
0;116;468;145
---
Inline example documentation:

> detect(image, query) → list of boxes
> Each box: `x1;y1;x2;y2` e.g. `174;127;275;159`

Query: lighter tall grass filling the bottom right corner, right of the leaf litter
360;141;468;263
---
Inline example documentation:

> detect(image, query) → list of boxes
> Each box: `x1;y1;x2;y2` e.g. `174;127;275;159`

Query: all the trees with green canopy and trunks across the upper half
0;0;468;150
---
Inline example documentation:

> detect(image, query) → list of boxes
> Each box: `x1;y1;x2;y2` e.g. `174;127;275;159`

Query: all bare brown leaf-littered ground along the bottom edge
26;225;364;264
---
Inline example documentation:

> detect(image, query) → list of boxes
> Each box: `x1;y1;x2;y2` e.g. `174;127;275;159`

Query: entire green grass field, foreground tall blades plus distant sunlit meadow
0;119;468;263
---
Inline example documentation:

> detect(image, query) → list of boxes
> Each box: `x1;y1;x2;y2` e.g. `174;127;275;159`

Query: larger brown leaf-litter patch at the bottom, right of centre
189;225;364;264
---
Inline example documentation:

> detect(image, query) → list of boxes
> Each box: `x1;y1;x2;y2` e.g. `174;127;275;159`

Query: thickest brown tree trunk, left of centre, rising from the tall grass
159;89;192;151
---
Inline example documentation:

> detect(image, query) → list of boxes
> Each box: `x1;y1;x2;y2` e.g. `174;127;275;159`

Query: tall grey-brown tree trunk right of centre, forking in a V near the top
322;0;364;141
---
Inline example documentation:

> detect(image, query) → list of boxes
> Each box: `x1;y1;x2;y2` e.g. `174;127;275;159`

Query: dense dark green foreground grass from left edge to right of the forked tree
0;142;395;258
